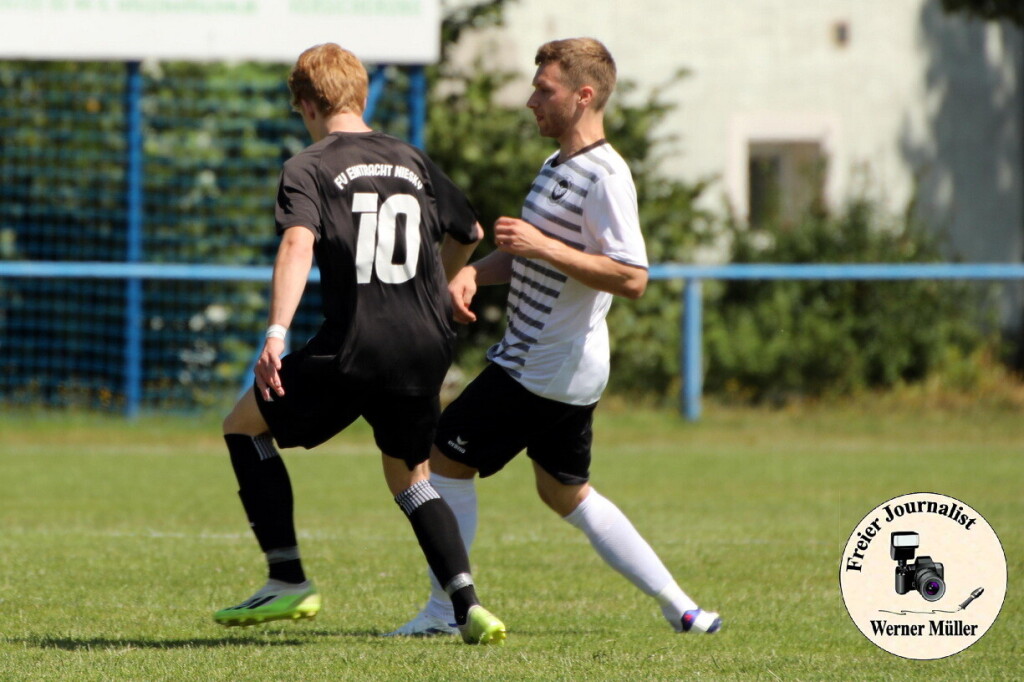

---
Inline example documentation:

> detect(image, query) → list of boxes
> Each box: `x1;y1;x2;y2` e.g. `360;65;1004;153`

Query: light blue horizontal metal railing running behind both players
0;261;1024;413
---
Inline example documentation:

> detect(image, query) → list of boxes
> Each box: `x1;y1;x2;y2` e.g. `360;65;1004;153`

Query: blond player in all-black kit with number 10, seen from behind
214;43;506;644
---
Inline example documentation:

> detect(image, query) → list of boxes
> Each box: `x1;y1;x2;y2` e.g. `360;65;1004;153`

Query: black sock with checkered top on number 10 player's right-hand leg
394;480;480;625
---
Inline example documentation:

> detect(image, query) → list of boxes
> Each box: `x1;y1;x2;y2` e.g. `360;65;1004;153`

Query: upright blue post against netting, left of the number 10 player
124;61;143;417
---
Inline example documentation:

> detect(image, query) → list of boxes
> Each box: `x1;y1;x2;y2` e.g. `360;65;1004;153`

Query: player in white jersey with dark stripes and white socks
391;38;722;636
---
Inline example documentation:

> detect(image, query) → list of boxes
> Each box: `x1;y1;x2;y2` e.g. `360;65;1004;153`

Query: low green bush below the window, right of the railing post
705;201;991;401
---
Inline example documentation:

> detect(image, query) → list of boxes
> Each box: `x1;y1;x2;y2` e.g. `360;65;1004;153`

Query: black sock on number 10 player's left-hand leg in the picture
224;433;306;583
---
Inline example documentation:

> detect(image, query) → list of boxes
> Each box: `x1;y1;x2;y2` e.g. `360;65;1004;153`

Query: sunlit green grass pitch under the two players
0;404;1024;681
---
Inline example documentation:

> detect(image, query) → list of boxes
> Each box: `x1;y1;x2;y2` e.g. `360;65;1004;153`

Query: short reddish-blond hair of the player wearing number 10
288;43;370;116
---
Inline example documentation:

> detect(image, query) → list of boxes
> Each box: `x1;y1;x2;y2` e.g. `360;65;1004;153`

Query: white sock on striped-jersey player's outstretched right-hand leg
564;488;697;629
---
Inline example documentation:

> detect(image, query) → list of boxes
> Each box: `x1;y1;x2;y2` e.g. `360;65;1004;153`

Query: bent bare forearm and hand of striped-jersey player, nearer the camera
495;217;647;299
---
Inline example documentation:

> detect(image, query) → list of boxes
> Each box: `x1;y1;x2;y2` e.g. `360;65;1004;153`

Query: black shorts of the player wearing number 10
253;348;440;469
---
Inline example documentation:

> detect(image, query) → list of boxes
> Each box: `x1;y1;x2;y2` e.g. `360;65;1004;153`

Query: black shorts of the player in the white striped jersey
434;364;597;485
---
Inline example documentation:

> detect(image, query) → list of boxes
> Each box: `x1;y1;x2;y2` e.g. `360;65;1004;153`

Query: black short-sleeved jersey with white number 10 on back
276;132;476;394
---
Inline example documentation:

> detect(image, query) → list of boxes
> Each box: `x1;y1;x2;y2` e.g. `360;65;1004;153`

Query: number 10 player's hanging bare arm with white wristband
256;227;315;400
